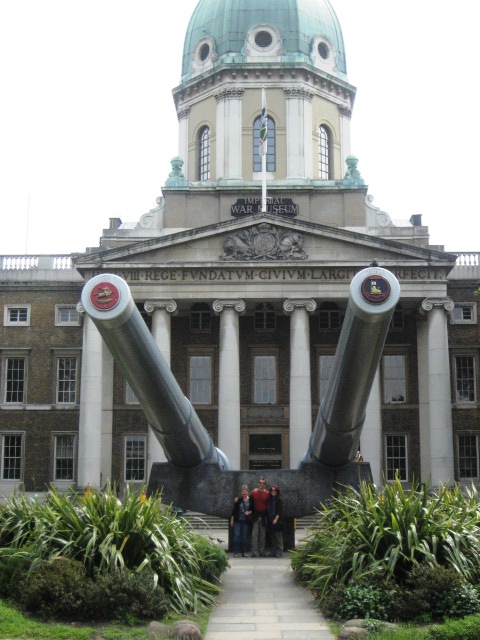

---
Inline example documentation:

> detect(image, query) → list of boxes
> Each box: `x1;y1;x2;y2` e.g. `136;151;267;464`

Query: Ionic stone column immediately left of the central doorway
213;300;245;469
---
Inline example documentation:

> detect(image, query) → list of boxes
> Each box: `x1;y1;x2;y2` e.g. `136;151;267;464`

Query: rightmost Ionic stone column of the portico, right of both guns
417;298;454;486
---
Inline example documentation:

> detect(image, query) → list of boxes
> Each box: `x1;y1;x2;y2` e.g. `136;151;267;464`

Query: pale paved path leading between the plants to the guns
205;554;335;640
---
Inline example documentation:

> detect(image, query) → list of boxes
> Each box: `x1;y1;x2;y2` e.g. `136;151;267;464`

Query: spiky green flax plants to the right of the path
292;479;480;600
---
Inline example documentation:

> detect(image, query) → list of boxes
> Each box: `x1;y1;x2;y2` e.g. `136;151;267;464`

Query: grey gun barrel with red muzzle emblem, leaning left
81;274;230;469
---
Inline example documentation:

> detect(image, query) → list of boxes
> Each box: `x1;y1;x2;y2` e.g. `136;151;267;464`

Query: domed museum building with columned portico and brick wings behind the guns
0;0;480;495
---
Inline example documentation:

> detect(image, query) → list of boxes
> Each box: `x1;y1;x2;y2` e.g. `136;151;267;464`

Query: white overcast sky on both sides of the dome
0;0;480;255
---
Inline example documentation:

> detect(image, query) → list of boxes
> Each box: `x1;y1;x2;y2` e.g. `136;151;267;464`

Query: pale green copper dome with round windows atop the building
182;0;347;81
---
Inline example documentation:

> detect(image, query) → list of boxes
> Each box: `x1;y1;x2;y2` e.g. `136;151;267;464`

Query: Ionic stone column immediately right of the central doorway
283;299;317;468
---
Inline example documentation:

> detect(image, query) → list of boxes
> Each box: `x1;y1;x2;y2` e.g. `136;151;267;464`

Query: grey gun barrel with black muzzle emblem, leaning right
303;267;400;467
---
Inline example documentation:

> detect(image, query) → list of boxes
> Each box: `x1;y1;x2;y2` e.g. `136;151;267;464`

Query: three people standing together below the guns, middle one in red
230;477;283;558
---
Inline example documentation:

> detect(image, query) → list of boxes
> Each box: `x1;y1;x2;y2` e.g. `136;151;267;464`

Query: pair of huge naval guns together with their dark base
82;266;400;519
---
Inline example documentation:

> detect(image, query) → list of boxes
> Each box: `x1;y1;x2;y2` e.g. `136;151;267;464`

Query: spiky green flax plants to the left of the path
0;487;228;613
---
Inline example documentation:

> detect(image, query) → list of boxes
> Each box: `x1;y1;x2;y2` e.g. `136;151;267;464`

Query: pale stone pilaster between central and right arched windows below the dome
284;86;313;178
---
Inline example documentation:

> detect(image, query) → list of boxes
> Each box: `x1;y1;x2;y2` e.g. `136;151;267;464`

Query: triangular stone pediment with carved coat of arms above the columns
75;214;455;273
